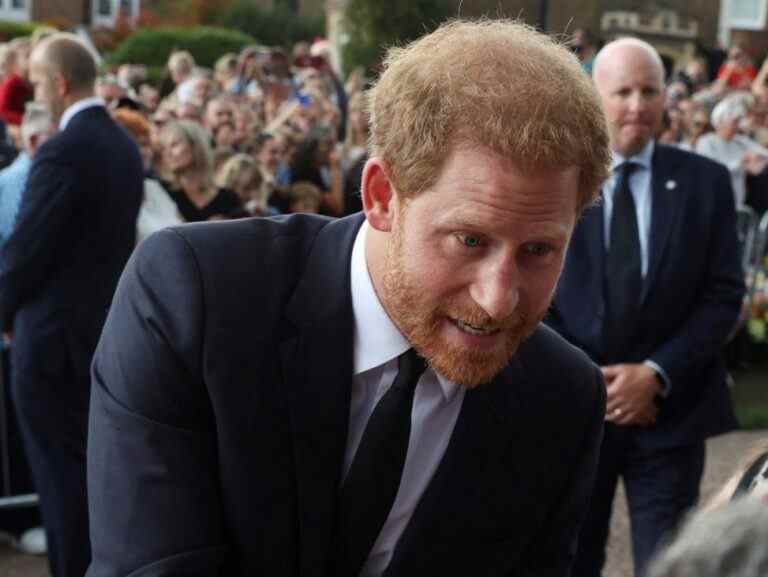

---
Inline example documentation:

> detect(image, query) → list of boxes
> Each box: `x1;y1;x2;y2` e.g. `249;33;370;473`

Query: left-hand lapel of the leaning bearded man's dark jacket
281;215;363;577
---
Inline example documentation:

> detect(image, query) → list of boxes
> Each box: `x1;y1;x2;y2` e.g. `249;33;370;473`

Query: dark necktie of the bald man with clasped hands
604;162;643;362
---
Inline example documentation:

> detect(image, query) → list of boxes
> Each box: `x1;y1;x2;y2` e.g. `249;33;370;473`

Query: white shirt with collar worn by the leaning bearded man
350;222;465;577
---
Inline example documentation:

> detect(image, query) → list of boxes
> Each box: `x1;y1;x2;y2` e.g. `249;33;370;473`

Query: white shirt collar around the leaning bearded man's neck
351;221;460;400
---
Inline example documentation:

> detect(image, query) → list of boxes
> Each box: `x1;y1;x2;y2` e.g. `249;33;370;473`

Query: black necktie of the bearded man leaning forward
333;349;426;577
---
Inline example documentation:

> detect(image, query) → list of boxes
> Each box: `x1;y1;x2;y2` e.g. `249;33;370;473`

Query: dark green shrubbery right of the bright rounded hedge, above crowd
218;0;325;48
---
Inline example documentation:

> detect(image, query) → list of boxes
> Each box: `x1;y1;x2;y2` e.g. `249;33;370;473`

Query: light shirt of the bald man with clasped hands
603;140;654;278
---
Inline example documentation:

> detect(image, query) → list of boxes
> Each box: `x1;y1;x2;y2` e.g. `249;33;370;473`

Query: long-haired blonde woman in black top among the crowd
154;120;245;222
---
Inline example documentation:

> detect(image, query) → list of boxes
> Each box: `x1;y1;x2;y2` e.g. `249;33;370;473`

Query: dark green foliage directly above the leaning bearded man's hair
343;0;453;70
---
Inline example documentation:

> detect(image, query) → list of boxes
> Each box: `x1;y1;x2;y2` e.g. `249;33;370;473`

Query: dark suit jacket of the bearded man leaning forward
88;215;605;577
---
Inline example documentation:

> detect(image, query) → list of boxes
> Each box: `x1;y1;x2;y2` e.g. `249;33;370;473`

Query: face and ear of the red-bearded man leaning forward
362;146;579;387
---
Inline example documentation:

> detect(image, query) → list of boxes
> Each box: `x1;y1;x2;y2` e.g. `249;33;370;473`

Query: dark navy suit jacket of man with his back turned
0;107;143;440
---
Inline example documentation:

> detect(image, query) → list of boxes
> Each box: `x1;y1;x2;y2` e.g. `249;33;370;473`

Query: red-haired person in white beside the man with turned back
112;108;182;243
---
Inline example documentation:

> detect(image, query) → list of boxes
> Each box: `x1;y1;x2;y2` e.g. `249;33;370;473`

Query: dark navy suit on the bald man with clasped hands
548;144;744;576
